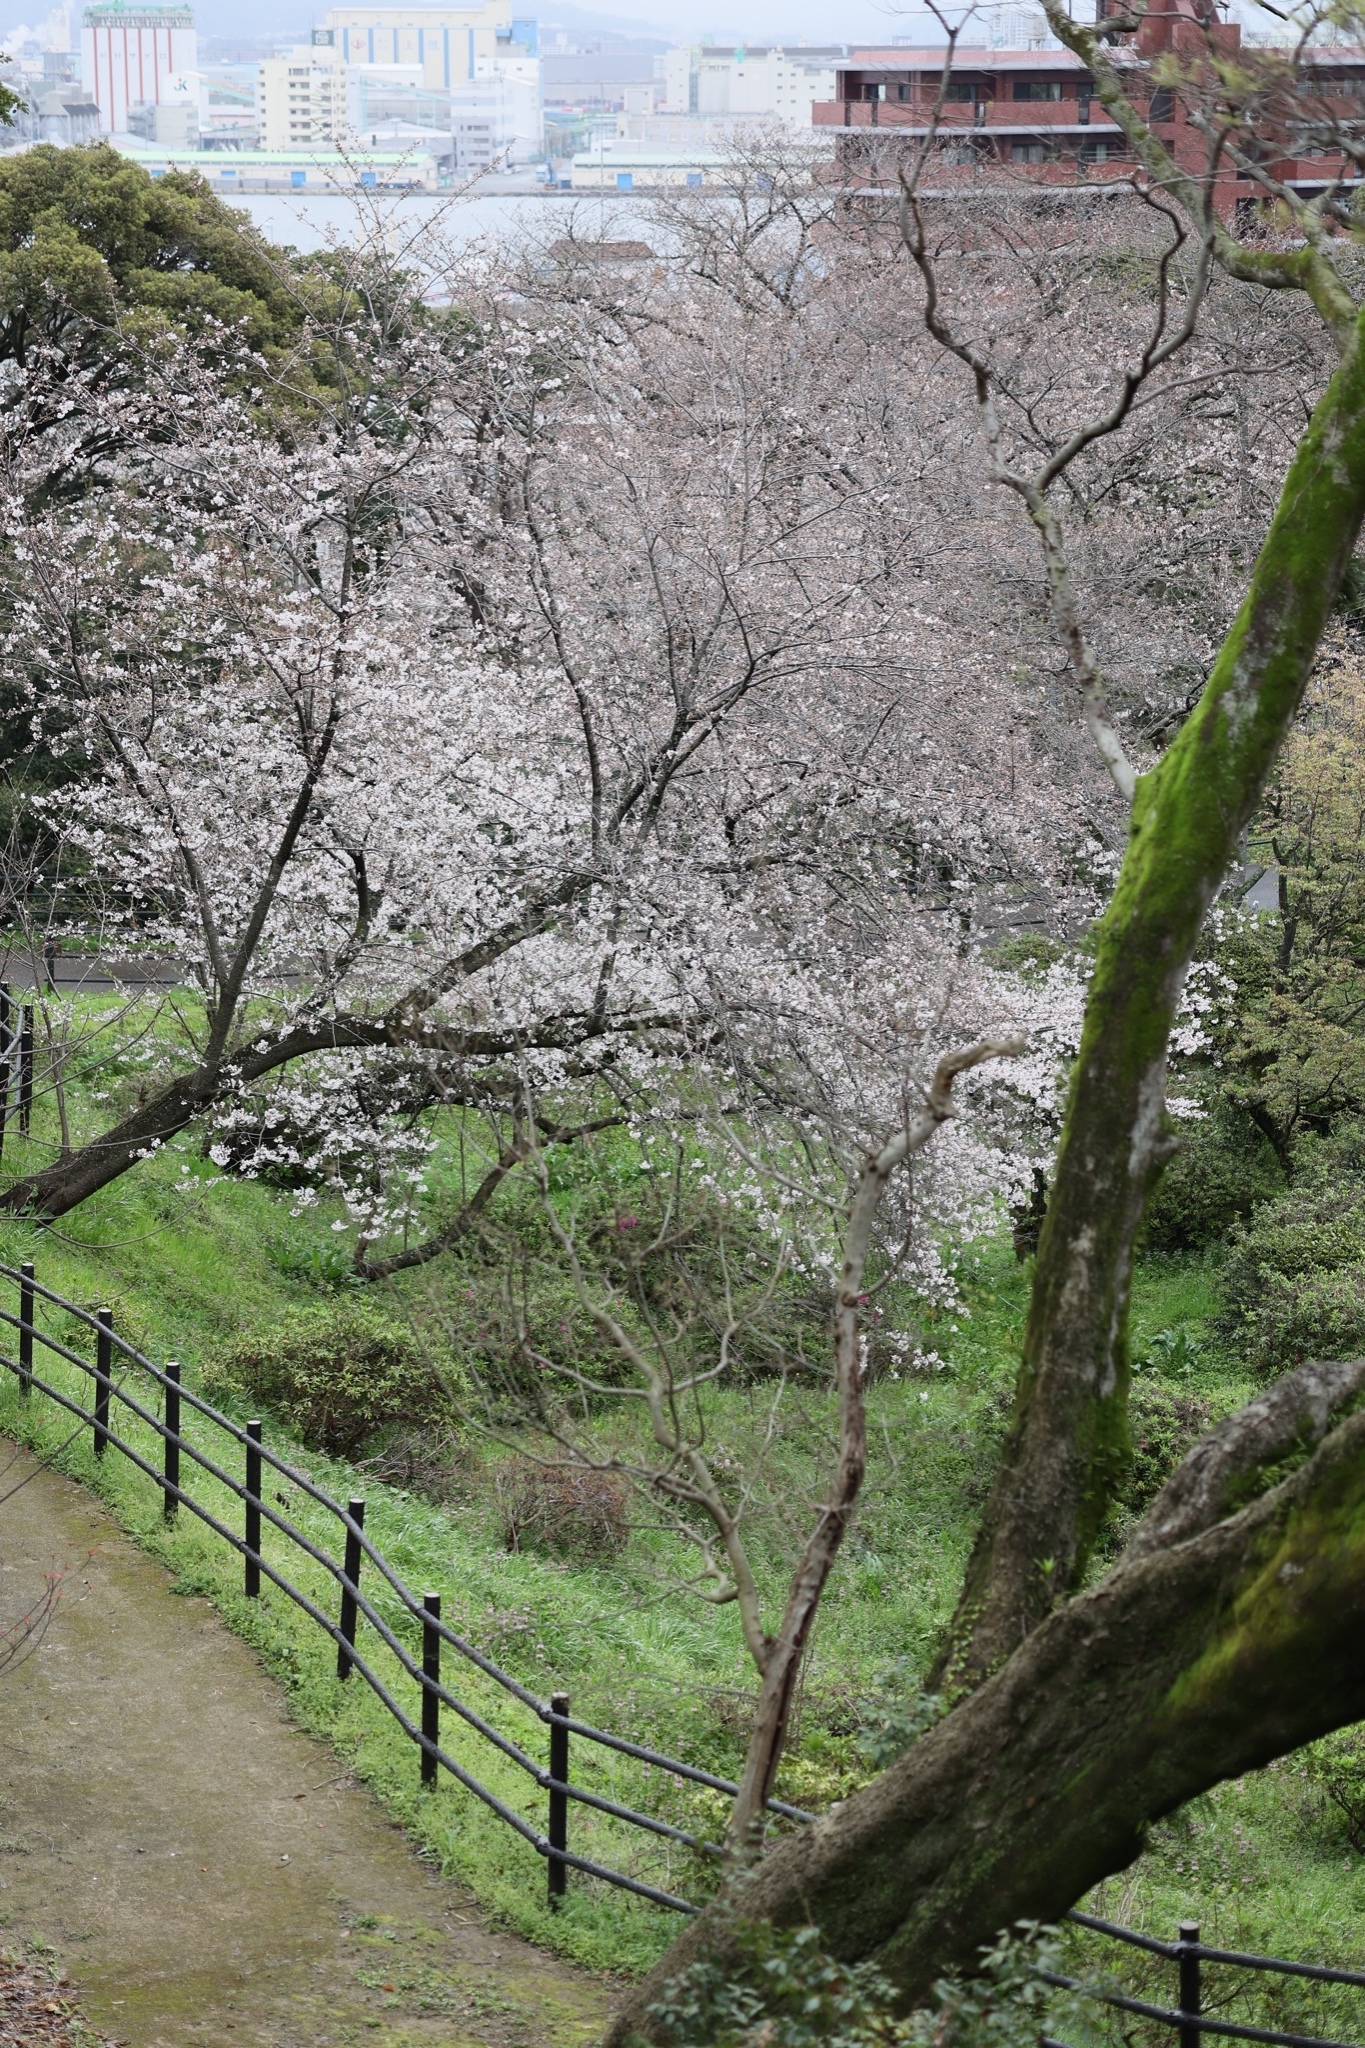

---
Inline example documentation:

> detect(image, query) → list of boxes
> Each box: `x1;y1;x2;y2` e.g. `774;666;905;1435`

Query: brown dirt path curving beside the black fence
0;1444;610;2048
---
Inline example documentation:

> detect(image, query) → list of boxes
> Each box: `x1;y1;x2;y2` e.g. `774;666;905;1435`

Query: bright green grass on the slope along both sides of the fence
0;1015;1365;2007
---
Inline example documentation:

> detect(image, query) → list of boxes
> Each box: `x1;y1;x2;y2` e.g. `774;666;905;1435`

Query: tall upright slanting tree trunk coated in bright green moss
931;296;1365;1692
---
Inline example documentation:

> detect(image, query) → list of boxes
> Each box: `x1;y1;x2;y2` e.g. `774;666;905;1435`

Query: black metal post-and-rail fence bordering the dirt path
0;1253;1365;2048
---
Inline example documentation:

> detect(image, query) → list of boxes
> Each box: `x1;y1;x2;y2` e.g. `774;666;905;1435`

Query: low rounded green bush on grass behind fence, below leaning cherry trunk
211;1296;454;1458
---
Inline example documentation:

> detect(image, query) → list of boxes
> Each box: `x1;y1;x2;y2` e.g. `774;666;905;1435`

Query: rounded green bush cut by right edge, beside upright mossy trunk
1218;1161;1365;1378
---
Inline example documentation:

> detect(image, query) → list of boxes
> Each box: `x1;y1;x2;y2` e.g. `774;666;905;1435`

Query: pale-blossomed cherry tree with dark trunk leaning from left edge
4;216;1076;1276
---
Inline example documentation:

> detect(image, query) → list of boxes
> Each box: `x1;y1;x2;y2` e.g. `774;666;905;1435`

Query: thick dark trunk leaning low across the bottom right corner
608;1415;1365;2048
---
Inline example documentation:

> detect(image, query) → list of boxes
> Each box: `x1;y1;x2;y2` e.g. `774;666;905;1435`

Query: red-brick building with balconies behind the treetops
812;0;1365;211
